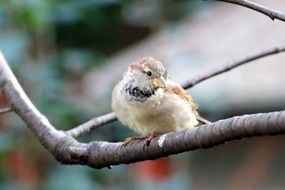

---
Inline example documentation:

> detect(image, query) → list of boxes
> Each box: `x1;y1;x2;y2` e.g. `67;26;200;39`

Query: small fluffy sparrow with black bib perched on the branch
112;57;209;145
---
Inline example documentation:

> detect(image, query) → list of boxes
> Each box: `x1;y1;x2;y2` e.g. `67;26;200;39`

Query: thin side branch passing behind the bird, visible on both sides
67;46;285;138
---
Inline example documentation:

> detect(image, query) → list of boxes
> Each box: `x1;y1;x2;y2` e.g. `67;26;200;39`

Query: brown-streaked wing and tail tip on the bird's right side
165;78;211;124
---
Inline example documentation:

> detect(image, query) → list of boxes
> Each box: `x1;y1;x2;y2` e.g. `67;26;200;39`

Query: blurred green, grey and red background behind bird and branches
0;0;285;190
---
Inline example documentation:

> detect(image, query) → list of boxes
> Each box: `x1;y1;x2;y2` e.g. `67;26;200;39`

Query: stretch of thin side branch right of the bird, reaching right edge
182;46;285;88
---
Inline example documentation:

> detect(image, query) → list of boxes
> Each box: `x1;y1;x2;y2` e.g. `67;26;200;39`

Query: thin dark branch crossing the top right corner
214;0;285;22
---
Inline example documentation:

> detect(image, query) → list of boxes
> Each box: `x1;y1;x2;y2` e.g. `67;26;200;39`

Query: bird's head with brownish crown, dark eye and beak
128;57;167;89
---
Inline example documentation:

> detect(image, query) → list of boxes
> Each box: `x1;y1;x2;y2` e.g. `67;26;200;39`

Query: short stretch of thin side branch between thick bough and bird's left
66;112;117;138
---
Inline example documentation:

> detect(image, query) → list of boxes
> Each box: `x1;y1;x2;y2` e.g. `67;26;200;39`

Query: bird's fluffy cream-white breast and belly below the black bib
112;83;198;134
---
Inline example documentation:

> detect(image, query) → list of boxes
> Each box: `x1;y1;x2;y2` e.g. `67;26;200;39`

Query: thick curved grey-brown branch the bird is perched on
0;53;285;168
